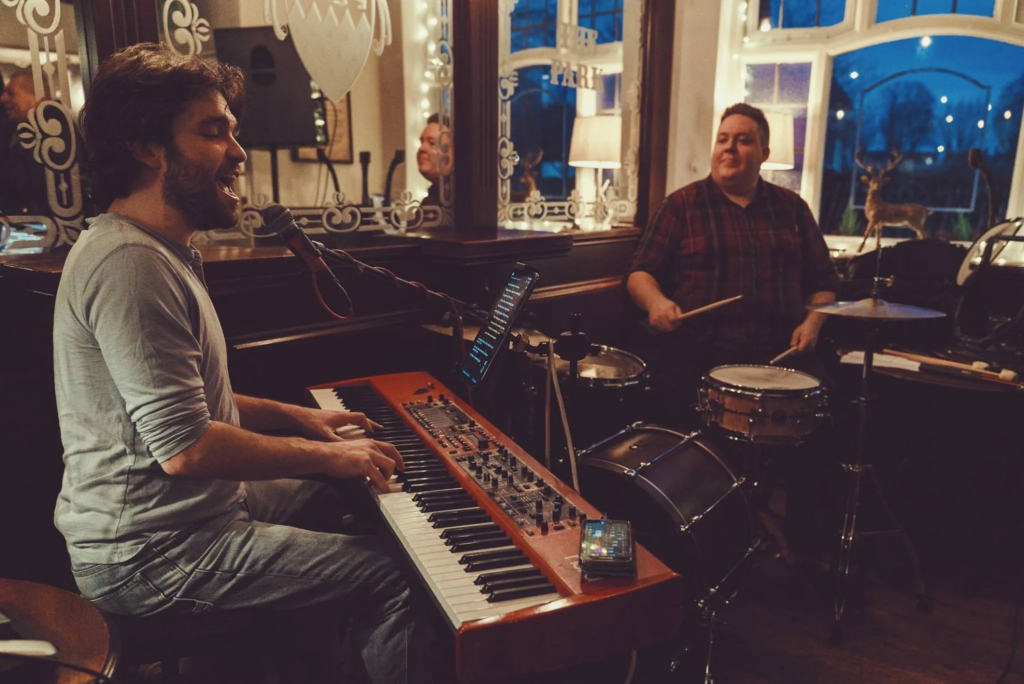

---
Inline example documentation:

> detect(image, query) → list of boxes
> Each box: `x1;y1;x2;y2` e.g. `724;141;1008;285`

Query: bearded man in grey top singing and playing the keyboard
53;44;429;682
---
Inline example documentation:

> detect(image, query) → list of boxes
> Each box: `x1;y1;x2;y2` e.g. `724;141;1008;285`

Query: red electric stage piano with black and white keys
309;373;683;681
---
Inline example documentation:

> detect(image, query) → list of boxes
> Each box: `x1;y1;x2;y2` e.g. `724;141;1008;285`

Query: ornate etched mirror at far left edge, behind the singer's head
0;0;87;254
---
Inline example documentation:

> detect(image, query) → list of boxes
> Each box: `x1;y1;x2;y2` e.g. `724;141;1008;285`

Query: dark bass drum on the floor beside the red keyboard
579;423;760;609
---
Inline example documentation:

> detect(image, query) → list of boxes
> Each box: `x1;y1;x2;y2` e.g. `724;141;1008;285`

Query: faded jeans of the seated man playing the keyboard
72;480;429;683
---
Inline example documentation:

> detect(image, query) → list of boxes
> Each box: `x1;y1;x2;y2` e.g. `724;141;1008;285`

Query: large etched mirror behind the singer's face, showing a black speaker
158;0;454;245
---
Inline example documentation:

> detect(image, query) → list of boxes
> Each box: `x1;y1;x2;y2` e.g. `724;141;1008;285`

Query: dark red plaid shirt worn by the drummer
630;176;839;349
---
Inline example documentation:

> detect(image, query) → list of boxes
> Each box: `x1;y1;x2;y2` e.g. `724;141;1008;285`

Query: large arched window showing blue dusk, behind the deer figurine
819;36;1024;240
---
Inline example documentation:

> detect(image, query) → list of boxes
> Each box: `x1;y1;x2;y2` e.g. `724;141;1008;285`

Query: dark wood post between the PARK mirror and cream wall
633;0;676;226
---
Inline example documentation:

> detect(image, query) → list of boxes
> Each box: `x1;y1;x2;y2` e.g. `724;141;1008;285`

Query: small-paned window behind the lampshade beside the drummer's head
743;62;811;193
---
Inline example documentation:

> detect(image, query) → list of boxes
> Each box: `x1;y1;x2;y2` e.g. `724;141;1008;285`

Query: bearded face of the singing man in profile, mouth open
164;92;246;230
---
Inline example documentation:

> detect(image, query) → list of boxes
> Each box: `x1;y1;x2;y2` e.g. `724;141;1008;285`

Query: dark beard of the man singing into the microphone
164;146;239;230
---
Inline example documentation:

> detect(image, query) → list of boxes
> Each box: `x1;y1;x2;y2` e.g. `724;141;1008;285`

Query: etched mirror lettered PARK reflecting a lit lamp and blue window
498;0;644;230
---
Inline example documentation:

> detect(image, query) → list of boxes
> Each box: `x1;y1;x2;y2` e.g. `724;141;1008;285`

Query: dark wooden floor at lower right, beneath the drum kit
713;548;1024;684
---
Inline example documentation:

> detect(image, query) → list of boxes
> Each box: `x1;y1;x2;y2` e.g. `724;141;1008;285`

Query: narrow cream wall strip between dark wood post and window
666;0;721;193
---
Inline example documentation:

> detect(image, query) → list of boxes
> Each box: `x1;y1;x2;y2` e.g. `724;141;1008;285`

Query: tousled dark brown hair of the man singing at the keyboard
80;43;245;211
